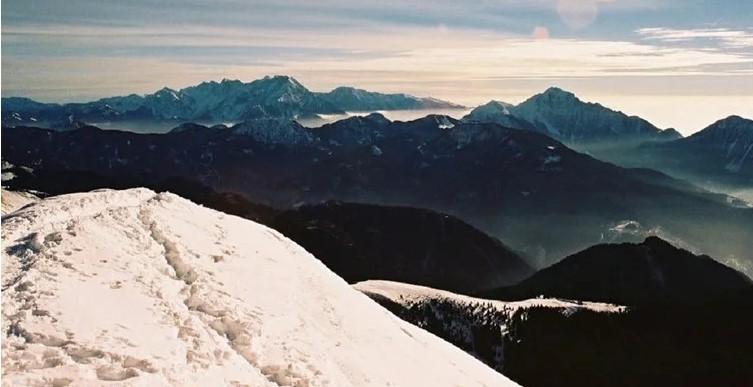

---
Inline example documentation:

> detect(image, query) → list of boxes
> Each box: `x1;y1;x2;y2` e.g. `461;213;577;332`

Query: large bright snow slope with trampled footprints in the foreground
2;189;513;386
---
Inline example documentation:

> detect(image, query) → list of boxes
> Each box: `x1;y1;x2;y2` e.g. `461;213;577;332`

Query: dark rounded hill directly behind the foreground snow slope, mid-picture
271;202;533;294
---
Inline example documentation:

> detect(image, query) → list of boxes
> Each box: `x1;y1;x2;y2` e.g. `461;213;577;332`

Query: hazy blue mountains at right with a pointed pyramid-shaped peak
463;87;753;190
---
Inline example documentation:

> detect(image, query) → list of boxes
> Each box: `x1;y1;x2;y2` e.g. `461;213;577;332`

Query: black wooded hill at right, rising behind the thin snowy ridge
484;237;753;305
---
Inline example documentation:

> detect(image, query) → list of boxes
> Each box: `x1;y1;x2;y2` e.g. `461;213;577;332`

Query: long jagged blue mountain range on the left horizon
2;76;460;129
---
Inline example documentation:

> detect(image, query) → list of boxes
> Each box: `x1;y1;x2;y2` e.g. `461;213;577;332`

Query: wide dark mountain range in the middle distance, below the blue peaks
2;114;753;270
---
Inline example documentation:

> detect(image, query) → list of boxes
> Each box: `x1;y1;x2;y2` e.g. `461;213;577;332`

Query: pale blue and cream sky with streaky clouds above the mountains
2;0;753;134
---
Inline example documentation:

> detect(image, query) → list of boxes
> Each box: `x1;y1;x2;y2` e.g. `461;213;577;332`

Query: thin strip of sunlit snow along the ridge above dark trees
353;280;627;313
